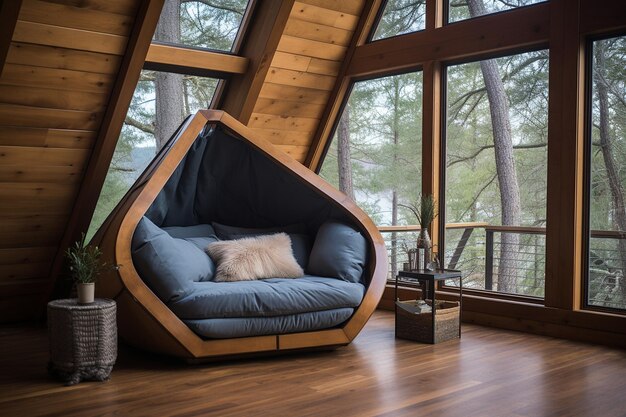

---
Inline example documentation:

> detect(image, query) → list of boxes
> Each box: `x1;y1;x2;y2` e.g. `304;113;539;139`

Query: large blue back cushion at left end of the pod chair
132;217;215;303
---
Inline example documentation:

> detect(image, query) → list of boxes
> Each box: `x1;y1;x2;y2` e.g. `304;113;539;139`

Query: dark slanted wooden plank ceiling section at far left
0;0;141;322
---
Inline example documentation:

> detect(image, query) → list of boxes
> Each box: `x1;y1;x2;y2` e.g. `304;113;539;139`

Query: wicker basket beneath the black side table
396;300;461;343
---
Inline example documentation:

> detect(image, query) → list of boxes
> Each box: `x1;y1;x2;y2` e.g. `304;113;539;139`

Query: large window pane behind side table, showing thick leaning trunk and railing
445;51;548;297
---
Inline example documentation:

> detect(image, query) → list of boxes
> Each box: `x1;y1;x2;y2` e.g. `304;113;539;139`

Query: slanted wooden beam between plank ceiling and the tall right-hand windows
304;0;382;172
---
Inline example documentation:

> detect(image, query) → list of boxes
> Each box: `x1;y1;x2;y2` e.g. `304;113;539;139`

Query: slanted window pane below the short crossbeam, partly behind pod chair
88;71;218;238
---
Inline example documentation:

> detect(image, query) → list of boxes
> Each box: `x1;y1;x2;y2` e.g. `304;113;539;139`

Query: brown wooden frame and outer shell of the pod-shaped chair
92;110;387;362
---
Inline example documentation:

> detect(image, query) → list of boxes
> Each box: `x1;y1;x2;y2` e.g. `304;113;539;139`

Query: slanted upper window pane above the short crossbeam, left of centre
154;0;248;51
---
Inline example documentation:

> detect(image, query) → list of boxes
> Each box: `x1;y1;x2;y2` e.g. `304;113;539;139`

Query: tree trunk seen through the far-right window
594;41;626;282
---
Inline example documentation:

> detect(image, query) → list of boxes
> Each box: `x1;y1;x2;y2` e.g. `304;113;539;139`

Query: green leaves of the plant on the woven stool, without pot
65;233;119;284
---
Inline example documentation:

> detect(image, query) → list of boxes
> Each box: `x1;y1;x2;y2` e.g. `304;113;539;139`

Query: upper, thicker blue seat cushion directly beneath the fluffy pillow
168;276;365;319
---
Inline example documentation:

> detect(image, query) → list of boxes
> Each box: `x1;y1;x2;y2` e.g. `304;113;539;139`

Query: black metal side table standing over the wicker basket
393;269;463;343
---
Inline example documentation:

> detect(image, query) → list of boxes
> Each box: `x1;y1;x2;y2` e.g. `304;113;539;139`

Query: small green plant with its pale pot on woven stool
65;233;118;304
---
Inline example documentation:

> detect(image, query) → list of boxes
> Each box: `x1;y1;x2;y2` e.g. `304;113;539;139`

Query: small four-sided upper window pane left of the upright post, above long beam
372;0;426;41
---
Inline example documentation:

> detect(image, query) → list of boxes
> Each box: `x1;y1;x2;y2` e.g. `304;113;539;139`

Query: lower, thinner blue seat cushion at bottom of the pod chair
184;308;354;339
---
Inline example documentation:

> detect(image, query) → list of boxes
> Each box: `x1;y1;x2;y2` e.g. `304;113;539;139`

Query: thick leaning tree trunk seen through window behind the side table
468;0;521;292
